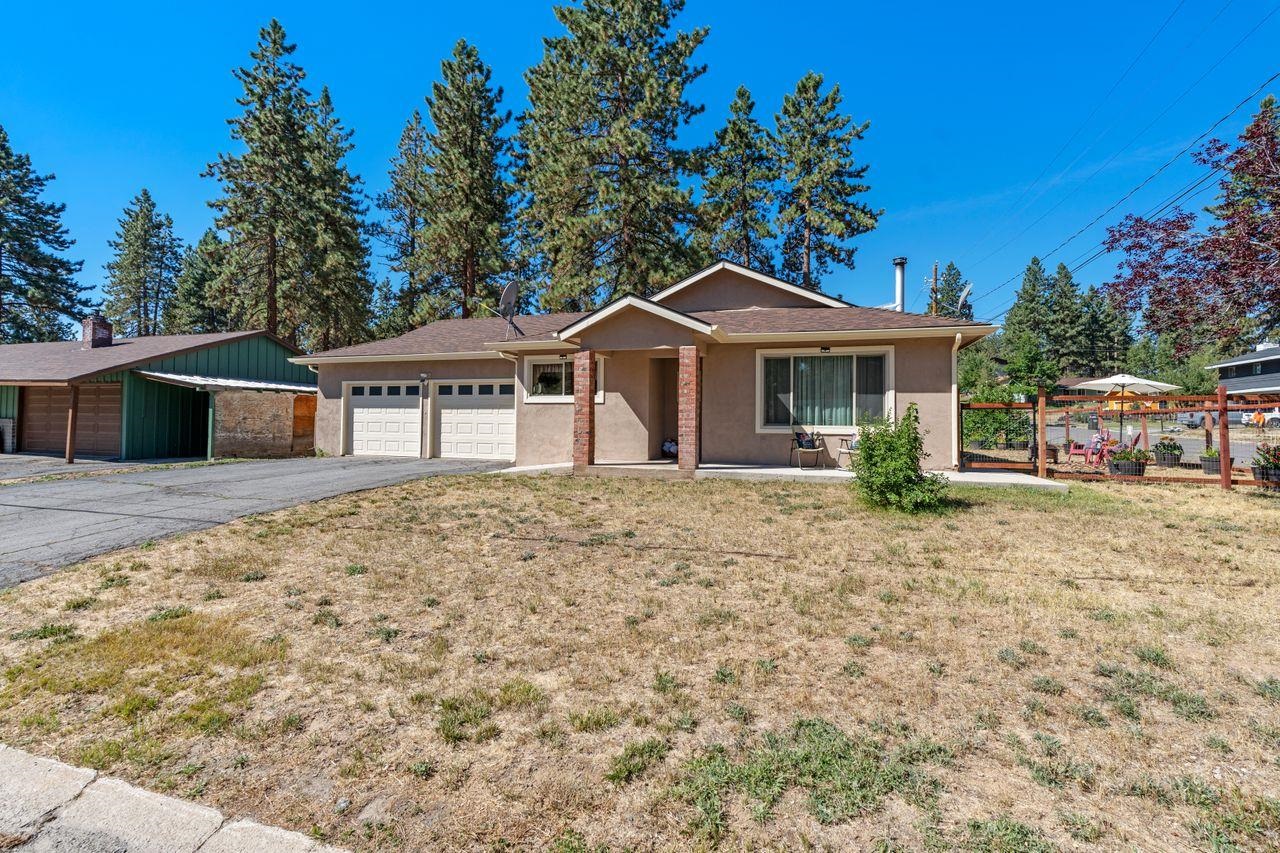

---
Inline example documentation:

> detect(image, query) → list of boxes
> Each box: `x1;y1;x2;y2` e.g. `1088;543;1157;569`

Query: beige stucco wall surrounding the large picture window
703;338;954;469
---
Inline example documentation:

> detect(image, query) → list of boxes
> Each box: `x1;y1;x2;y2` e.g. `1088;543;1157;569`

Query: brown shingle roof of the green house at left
0;332;281;383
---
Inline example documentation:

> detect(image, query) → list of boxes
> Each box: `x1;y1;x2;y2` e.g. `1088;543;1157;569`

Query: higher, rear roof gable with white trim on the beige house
649;260;849;311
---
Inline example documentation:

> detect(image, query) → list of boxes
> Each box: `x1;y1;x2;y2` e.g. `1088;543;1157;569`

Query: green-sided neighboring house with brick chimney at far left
0;316;315;462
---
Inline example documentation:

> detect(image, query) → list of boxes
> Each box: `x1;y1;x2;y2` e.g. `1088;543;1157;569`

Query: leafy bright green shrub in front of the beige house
854;403;947;512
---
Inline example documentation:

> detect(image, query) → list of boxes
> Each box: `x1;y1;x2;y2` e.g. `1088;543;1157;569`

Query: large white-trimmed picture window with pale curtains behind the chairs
756;352;890;432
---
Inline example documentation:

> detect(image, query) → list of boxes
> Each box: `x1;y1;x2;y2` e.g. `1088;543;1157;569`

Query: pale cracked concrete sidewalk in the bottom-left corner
0;744;338;853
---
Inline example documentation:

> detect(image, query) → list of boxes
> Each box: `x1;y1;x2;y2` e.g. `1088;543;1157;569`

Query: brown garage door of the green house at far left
18;383;120;456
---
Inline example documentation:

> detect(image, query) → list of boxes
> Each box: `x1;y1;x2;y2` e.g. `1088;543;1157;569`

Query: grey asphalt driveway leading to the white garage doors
0;457;506;588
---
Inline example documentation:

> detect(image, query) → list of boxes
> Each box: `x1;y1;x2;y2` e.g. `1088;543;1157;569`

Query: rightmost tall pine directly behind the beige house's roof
777;72;883;289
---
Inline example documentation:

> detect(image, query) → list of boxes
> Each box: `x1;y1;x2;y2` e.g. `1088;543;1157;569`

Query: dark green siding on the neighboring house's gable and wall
119;337;316;459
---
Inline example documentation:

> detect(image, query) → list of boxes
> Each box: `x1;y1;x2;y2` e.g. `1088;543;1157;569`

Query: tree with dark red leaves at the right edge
1106;96;1280;355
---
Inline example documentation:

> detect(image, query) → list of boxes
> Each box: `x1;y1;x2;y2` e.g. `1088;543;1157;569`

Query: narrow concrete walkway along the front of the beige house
498;462;1070;492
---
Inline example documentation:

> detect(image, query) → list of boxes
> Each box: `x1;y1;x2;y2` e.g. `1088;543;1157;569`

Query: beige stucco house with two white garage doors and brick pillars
294;261;993;473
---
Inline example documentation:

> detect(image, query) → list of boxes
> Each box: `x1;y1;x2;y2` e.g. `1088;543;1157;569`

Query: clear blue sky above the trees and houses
0;0;1280;318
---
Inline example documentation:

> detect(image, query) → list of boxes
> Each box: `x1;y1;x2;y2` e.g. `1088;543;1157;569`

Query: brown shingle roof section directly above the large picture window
691;306;986;334
